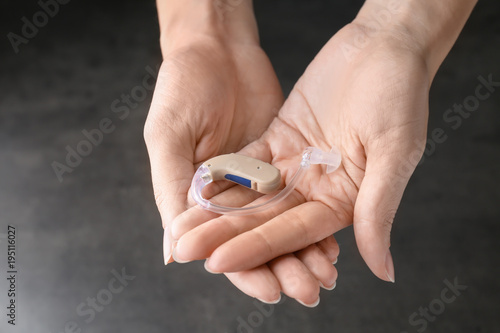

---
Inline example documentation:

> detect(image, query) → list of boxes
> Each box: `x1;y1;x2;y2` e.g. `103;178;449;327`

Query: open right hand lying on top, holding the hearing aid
172;24;431;288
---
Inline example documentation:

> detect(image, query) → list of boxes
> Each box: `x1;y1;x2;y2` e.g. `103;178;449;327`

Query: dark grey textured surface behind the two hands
0;0;500;333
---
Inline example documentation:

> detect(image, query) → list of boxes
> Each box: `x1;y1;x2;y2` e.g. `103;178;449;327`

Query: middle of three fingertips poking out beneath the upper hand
268;254;320;307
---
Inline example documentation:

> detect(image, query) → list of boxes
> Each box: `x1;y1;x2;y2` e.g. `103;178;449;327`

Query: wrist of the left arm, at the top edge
157;0;259;56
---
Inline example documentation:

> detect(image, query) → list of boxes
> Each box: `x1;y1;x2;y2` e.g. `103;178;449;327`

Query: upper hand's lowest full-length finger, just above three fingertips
206;201;348;272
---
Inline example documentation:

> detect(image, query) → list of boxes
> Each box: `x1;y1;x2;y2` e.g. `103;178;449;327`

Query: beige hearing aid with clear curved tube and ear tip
191;147;341;216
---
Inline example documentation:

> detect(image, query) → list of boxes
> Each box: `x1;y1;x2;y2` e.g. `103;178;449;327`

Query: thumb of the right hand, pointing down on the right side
353;149;418;282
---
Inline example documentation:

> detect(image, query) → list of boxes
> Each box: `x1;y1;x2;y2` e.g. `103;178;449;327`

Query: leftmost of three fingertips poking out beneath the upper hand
225;265;281;304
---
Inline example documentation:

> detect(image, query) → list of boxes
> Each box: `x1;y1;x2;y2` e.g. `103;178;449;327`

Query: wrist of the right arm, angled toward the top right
353;0;477;79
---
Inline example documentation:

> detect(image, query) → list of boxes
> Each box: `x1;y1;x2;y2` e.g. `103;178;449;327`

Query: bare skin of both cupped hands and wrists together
145;1;475;306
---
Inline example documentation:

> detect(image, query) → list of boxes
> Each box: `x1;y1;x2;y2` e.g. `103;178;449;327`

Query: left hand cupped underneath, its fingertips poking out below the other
144;36;338;304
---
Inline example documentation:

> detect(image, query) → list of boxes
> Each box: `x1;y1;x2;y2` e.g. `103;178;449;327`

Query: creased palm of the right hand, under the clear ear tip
265;23;428;225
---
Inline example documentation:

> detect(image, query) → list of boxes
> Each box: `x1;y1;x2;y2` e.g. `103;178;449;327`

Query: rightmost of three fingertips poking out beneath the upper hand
295;244;337;290
